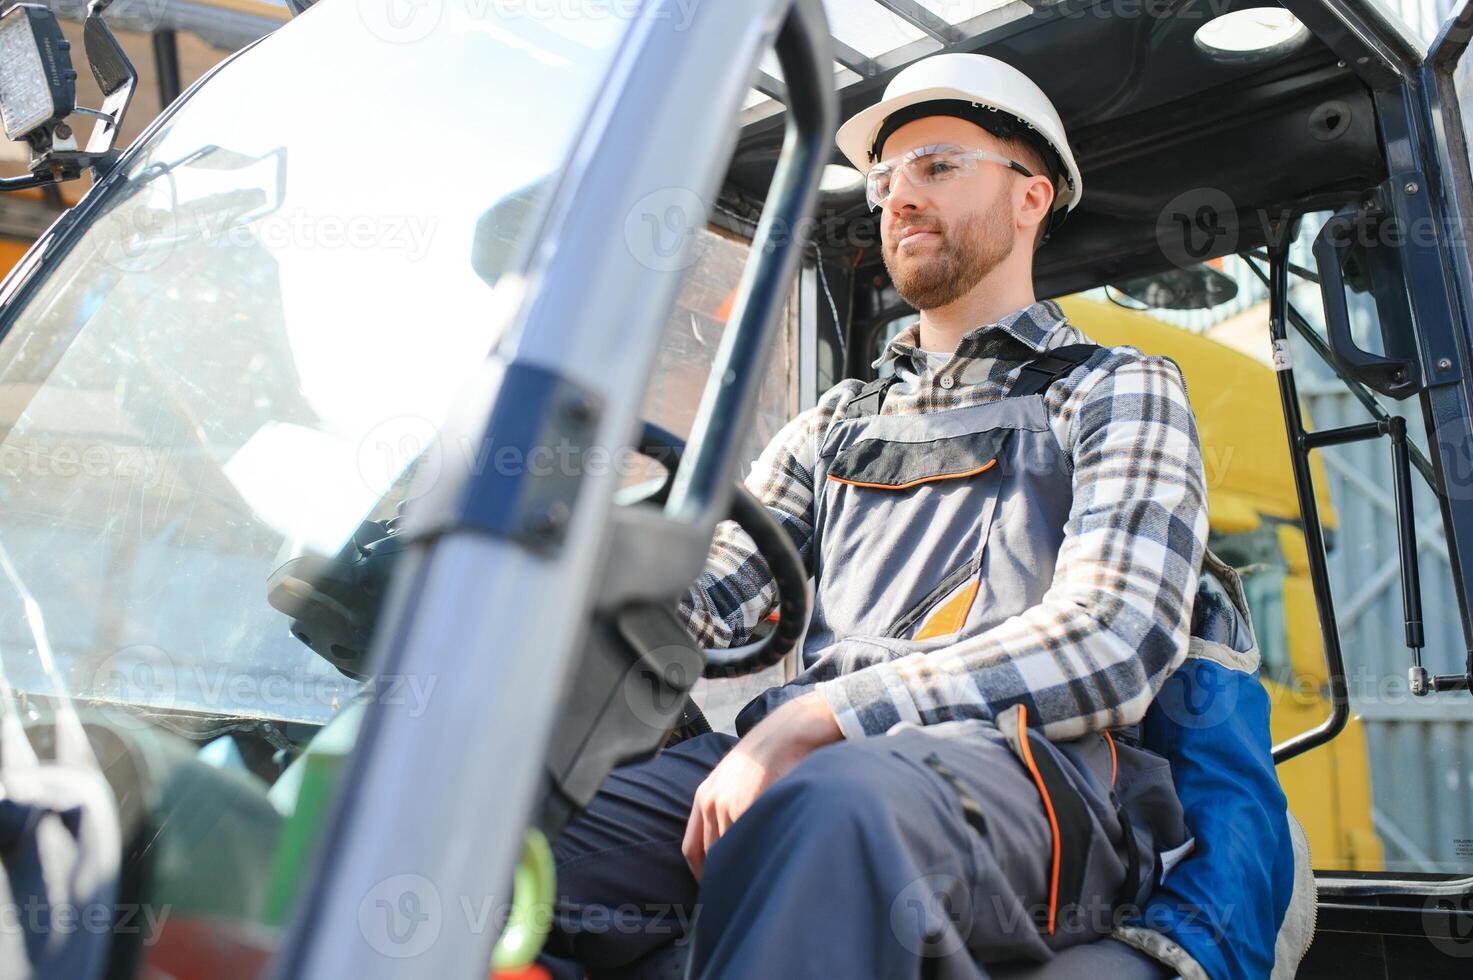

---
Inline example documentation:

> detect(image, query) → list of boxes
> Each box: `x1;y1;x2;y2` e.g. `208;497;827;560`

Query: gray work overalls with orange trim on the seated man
548;345;1207;980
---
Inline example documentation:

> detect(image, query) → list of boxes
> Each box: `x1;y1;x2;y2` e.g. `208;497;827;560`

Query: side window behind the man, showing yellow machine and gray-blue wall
1095;221;1473;874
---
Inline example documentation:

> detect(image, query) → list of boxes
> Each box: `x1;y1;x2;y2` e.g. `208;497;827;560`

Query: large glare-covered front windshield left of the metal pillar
0;3;626;722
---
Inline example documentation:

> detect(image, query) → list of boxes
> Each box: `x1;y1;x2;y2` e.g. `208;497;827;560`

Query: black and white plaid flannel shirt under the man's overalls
681;294;1208;738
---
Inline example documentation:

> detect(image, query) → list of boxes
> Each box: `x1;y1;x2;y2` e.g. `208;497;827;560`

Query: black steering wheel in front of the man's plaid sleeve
636;421;809;678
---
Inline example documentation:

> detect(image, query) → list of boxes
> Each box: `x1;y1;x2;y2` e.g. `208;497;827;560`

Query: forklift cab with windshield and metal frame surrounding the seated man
0;0;1473;977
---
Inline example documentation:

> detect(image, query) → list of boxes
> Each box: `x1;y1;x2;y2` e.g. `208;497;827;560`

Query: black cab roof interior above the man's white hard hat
726;0;1396;296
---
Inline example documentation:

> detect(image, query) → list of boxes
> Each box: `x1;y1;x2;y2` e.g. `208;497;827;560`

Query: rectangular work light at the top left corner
0;3;77;140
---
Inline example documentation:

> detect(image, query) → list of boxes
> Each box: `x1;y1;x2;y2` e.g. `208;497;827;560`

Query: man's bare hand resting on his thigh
681;694;843;880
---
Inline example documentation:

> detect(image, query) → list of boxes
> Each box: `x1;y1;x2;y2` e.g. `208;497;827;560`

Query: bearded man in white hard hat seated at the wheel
551;55;1208;979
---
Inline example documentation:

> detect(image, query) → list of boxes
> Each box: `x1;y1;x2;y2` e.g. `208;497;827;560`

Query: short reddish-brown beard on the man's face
881;195;1013;309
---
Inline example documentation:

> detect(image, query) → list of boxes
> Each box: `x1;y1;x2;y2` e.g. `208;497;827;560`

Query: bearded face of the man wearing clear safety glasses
879;116;1019;309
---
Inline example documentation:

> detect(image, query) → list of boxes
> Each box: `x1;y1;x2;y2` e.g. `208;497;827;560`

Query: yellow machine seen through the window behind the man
1059;296;1382;871
